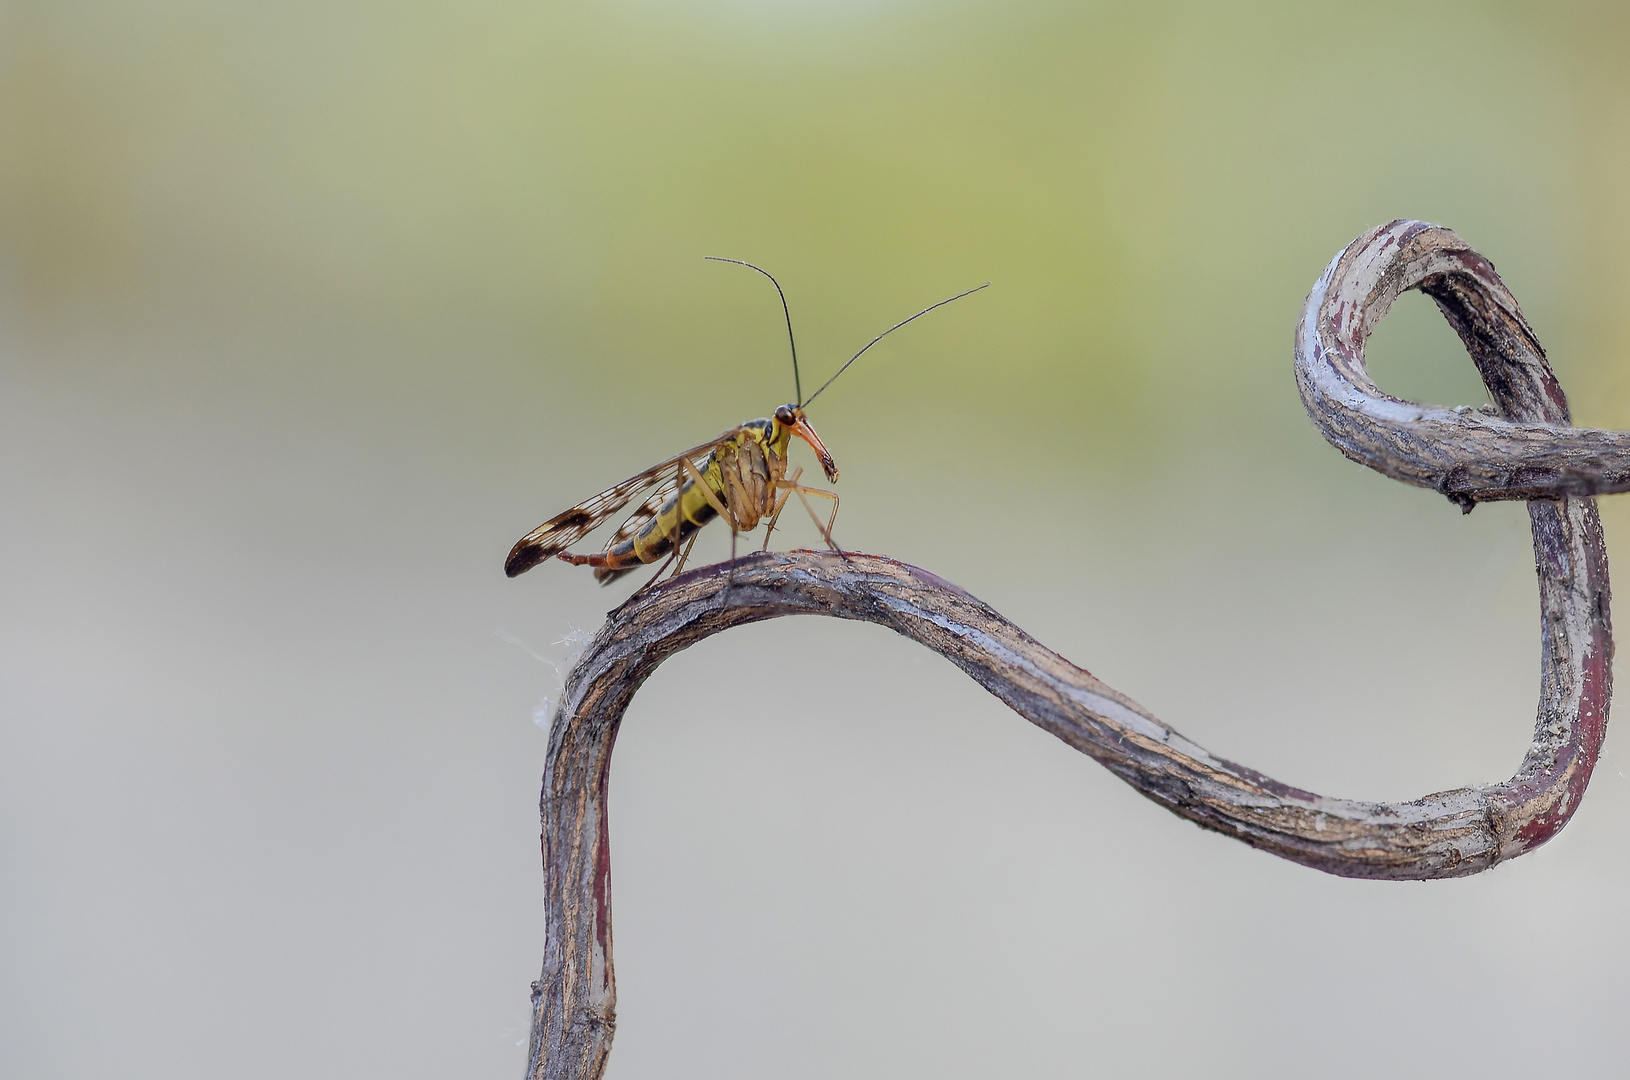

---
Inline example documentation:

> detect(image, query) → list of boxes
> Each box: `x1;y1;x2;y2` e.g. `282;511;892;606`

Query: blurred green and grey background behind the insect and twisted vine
0;0;1630;1078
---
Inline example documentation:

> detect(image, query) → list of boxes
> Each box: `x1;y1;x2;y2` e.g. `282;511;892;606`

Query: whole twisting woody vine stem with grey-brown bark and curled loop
528;222;1610;1080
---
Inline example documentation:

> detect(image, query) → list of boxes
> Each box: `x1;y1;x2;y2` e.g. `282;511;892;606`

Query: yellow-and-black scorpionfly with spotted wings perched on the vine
504;256;989;585
